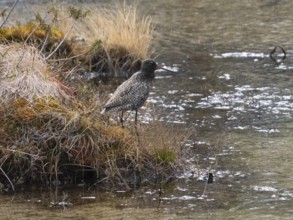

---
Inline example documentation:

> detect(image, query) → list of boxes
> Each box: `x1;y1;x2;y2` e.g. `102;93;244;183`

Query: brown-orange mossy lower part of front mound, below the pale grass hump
0;99;177;188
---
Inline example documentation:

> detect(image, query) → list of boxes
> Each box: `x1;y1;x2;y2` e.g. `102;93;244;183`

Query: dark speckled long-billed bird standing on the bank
101;59;160;123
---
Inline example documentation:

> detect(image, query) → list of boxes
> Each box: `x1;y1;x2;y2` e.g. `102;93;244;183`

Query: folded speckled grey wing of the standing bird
105;81;149;110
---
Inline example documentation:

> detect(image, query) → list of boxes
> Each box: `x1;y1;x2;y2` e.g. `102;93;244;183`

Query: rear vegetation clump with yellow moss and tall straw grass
0;3;153;79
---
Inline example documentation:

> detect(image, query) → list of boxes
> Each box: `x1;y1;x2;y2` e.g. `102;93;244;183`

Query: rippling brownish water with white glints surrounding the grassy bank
0;0;293;219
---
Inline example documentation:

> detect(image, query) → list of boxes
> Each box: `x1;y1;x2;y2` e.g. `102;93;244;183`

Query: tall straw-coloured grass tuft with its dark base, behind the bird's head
75;3;153;76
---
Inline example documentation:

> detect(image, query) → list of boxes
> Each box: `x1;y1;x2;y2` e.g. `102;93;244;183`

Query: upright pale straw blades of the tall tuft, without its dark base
73;3;153;59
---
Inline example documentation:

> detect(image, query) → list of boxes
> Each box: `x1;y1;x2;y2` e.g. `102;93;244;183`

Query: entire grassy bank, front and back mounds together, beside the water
0;2;188;191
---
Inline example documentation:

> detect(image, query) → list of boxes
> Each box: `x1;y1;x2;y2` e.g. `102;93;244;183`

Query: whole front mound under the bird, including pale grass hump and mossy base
0;44;181;191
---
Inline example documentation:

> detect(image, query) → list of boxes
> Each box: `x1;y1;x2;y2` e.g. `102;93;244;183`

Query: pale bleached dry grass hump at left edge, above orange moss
0;44;69;102
